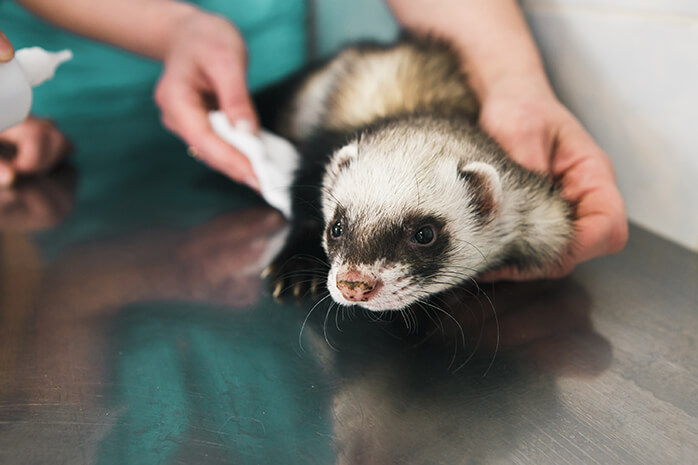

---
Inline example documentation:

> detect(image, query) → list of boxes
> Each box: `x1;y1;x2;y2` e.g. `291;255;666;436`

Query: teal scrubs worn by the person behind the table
0;0;306;121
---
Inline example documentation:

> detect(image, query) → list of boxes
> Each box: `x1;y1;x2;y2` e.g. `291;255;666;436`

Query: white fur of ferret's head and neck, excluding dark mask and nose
322;120;569;310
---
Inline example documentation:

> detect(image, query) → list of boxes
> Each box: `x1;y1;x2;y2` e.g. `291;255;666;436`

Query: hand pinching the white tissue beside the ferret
155;11;260;191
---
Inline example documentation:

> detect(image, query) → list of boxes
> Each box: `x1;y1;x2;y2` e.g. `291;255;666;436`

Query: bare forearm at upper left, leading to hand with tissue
19;0;197;59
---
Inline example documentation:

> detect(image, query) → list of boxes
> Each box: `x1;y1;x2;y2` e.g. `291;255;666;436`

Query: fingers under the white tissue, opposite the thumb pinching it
156;77;259;190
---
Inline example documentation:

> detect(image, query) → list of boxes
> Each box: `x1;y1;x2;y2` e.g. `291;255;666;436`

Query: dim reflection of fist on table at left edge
0;165;76;232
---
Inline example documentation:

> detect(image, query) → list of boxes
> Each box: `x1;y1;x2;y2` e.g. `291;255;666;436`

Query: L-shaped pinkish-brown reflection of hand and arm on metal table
23;207;283;407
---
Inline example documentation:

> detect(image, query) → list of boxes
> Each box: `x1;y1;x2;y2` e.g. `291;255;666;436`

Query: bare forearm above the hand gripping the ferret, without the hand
388;0;551;100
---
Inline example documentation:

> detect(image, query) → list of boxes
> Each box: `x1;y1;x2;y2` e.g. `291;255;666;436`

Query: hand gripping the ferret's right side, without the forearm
480;83;628;281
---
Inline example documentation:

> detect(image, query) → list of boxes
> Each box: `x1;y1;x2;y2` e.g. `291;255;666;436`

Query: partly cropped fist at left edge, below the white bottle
0;116;70;187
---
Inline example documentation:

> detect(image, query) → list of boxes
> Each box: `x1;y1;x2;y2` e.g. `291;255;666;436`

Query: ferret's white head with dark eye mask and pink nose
322;125;502;311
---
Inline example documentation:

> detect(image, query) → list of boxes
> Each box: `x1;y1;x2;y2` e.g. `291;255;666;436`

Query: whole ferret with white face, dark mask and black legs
257;36;574;311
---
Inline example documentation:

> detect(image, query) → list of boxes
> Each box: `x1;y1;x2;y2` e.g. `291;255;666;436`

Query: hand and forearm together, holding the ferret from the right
389;0;628;280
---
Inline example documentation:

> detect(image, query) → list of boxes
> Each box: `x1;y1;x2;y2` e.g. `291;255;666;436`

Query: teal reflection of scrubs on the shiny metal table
96;302;335;465
